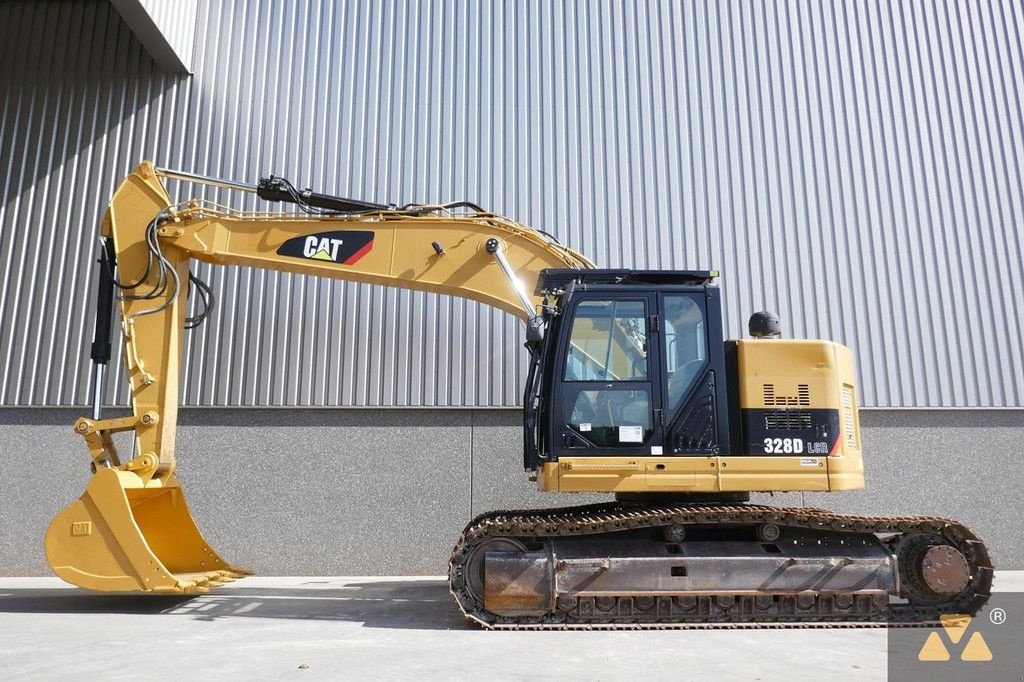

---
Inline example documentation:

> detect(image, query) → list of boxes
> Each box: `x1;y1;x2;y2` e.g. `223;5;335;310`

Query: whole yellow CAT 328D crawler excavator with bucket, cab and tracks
45;162;992;629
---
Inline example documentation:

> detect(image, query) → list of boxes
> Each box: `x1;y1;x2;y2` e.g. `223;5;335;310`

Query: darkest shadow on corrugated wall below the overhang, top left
0;0;188;215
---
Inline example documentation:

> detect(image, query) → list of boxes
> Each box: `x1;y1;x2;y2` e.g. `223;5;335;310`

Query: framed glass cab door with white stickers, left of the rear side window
550;292;664;458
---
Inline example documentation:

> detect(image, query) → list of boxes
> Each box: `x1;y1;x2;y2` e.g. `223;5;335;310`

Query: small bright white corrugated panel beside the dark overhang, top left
111;0;199;73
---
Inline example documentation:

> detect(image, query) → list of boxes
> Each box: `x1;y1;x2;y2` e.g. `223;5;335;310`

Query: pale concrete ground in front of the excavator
0;571;1024;681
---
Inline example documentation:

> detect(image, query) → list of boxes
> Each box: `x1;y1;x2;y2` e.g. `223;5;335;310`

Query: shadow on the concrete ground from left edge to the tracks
0;580;470;630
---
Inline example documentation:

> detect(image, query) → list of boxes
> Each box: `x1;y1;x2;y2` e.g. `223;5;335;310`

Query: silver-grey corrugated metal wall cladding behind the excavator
0;0;1024;407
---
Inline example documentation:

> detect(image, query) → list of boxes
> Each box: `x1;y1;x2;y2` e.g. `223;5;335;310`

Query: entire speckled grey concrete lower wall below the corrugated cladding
0;409;1024;576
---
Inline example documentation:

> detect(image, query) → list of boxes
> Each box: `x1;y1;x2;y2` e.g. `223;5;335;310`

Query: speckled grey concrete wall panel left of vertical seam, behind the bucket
0;410;475;576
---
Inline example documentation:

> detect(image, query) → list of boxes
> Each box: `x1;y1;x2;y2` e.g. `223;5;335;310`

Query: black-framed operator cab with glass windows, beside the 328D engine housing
524;269;729;468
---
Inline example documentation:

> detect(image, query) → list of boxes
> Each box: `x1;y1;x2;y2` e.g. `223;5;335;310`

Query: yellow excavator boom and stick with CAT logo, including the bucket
46;162;594;593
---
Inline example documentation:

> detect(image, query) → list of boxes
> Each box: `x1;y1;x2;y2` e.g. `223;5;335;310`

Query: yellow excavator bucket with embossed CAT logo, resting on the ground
46;468;250;594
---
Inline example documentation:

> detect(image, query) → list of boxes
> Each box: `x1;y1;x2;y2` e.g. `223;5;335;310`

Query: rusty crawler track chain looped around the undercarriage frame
449;503;992;630
